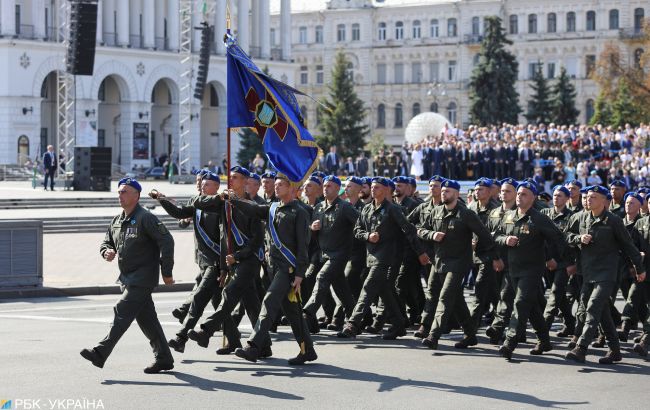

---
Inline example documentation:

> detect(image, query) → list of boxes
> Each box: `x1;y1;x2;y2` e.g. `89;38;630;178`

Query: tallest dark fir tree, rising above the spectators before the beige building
469;16;521;125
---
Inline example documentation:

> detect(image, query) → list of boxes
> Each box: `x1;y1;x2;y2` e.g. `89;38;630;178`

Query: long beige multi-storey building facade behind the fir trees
271;0;650;146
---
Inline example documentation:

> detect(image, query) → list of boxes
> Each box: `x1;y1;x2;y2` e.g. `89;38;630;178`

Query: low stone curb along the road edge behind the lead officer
0;282;195;300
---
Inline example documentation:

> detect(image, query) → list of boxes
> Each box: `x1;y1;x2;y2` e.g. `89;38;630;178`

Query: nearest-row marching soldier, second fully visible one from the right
496;182;567;360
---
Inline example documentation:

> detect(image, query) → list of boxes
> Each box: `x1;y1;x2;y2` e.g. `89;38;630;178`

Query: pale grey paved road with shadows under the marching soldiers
0;293;650;409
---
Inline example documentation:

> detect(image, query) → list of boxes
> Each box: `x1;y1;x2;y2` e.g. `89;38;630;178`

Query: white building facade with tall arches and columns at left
0;0;295;172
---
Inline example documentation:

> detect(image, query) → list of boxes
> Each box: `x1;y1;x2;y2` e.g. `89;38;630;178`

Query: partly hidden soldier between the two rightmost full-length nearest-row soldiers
541;185;575;337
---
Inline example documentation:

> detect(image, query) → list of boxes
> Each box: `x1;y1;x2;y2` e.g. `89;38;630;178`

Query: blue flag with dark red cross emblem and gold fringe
226;36;318;183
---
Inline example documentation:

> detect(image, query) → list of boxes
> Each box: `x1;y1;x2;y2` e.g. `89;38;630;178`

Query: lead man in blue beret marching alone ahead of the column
81;178;174;373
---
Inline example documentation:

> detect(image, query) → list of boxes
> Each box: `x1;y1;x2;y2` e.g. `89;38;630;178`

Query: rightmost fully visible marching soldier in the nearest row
566;186;645;364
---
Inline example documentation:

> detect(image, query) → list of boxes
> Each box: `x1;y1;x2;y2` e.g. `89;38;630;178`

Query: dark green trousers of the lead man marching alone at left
95;286;174;363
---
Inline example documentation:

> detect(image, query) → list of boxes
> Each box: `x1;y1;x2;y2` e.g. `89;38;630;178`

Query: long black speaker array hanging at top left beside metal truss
66;0;97;75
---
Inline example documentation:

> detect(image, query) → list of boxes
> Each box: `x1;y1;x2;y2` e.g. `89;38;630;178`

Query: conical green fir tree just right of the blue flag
316;50;368;157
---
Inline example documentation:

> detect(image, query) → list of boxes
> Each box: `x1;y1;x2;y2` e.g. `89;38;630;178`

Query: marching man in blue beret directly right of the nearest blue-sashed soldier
303;175;359;333
